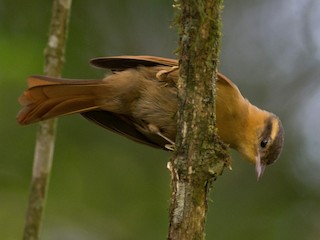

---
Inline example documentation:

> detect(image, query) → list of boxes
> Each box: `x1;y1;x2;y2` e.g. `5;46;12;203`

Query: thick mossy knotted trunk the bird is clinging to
168;0;228;240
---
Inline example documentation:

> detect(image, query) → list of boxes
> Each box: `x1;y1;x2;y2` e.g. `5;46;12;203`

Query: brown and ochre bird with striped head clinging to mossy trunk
17;56;284;179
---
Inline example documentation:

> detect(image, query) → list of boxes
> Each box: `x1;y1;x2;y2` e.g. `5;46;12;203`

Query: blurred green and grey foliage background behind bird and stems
0;0;320;240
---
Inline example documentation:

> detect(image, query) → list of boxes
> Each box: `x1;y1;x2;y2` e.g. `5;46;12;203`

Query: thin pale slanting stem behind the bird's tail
23;0;71;240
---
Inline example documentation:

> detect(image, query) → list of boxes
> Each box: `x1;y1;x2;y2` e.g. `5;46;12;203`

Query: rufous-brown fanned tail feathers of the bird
17;76;103;124
